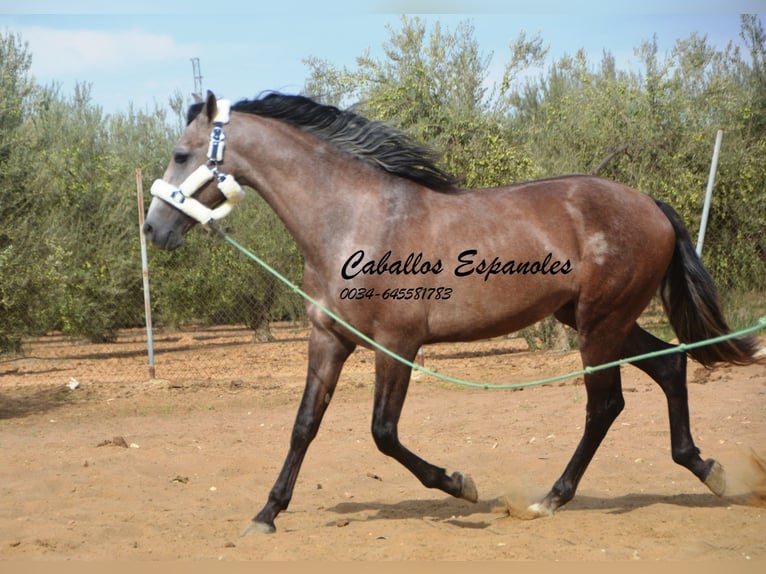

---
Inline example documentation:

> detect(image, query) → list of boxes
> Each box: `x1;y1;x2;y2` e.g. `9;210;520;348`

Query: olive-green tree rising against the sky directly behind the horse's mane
305;17;533;187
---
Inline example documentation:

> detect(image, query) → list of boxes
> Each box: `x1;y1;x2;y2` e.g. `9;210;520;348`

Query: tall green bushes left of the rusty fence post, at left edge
0;38;180;352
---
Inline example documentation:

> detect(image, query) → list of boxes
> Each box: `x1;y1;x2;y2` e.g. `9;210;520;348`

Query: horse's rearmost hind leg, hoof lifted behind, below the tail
623;325;726;496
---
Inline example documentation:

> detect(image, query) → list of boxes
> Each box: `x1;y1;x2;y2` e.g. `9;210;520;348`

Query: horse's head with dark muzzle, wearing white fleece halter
144;92;244;249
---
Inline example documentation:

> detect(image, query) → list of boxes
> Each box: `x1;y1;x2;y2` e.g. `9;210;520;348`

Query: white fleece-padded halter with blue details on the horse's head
151;100;245;226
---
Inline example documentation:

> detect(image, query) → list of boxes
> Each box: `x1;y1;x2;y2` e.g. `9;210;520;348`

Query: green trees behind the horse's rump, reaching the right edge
507;16;766;290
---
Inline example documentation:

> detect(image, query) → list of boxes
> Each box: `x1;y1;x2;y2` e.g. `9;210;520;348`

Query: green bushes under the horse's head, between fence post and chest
150;191;303;340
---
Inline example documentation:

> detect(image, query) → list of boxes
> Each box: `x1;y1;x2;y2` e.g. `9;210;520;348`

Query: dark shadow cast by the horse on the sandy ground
327;493;749;529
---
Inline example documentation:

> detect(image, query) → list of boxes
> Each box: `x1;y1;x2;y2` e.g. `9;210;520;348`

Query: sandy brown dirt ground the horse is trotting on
0;328;766;561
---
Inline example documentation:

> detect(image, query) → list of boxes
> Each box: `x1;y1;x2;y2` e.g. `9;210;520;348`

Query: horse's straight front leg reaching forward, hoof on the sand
243;326;354;535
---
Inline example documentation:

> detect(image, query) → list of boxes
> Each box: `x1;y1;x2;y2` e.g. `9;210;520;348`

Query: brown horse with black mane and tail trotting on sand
143;92;758;533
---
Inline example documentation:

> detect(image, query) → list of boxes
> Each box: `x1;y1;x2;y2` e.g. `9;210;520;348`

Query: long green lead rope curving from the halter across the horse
208;223;766;390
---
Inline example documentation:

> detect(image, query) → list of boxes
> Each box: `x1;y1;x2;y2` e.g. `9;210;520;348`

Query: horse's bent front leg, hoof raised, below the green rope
372;347;479;502
